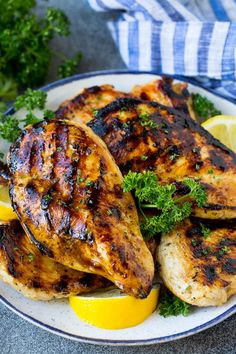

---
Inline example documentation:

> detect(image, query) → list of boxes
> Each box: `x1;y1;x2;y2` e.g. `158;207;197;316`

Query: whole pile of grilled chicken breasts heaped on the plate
0;79;236;306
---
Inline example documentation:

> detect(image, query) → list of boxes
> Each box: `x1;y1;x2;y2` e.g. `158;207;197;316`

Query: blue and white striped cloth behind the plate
88;0;236;99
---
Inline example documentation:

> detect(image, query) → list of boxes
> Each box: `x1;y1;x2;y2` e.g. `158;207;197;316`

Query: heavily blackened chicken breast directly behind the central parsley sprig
88;98;236;219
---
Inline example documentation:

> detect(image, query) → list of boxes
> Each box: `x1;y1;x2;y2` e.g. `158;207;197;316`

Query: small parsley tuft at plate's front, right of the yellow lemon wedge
159;292;190;317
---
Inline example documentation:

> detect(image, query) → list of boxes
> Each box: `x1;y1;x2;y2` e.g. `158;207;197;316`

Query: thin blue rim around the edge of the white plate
0;70;236;346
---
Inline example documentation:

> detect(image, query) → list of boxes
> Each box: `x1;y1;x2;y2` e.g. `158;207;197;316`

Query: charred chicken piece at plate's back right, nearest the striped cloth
131;78;195;119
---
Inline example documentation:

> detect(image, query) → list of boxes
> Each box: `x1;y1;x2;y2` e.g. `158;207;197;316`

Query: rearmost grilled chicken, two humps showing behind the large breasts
55;78;194;124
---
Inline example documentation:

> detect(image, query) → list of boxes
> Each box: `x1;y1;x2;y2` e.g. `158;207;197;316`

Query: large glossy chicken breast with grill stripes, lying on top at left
9;120;154;298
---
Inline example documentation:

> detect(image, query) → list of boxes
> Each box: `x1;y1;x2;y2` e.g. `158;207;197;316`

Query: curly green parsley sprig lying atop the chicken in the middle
123;171;207;239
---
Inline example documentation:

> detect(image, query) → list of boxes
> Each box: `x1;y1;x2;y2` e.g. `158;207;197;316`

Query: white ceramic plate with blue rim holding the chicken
0;71;236;345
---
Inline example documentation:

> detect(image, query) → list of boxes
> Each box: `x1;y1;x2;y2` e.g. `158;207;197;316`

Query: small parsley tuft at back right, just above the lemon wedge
192;93;222;119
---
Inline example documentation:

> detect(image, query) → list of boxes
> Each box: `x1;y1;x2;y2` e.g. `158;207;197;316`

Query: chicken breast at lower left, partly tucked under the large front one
0;220;111;300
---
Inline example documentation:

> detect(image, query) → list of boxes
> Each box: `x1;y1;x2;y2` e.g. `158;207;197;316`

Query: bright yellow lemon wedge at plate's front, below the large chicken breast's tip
69;286;159;329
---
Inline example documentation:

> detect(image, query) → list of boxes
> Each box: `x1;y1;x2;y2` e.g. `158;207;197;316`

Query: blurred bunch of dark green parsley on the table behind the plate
0;0;81;111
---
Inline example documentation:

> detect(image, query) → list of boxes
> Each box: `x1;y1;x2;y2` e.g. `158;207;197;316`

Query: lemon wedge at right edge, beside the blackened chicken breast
202;115;236;152
